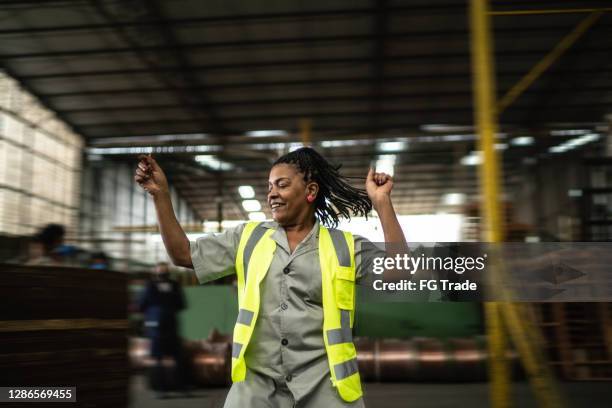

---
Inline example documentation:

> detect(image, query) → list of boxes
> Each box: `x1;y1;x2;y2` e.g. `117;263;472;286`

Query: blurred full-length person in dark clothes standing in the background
139;262;186;398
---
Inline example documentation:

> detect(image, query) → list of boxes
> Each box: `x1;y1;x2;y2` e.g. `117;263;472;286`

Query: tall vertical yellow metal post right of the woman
470;0;510;408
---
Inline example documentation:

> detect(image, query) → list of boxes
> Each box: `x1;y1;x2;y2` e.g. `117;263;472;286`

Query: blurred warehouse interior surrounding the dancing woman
0;0;612;408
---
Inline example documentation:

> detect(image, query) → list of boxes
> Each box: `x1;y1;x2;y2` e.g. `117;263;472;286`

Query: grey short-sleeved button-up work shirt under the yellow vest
191;222;384;408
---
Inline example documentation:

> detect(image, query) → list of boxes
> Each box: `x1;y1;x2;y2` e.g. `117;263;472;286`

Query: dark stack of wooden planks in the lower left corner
0;265;129;407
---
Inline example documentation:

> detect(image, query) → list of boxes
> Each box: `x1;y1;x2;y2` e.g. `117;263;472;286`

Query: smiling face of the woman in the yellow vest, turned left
268;163;318;225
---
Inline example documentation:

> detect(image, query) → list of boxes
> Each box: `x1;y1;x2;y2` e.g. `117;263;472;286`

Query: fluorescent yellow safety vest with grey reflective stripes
232;222;363;402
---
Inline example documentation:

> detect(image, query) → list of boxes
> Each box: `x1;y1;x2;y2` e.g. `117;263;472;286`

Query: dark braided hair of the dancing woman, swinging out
273;147;372;228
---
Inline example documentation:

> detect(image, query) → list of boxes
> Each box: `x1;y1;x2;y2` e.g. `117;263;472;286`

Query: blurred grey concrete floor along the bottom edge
130;376;612;408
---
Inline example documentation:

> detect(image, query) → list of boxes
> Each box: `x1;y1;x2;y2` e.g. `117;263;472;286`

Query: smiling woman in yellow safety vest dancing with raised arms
135;148;406;408
